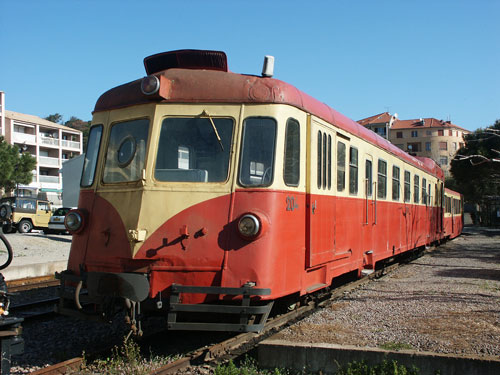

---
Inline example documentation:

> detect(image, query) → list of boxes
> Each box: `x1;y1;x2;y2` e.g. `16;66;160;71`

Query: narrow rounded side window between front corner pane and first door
283;118;300;186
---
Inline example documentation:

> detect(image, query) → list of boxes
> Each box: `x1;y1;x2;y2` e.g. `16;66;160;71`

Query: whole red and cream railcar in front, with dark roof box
58;50;458;331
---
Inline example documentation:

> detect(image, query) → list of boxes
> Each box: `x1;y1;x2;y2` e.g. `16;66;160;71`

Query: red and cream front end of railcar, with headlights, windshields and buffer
57;70;305;331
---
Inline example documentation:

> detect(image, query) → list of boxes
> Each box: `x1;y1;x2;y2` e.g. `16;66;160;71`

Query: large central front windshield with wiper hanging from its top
155;116;234;182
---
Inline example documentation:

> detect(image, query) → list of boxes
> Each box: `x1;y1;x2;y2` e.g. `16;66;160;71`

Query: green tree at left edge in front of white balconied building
0;137;36;191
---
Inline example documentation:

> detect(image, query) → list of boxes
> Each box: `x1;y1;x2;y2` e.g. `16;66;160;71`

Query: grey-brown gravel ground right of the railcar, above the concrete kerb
276;228;500;359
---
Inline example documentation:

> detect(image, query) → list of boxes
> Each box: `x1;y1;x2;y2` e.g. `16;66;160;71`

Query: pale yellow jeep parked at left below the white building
0;197;52;233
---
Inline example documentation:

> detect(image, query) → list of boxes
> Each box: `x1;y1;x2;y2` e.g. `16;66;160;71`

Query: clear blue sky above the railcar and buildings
0;0;500;130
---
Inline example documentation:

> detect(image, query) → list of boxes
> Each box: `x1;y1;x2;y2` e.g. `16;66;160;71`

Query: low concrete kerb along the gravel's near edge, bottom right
258;338;500;375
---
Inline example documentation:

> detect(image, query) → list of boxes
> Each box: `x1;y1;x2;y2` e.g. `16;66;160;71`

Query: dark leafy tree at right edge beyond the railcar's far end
451;120;500;203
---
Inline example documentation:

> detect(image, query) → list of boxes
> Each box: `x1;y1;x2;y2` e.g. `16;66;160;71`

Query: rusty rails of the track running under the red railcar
26;248;418;375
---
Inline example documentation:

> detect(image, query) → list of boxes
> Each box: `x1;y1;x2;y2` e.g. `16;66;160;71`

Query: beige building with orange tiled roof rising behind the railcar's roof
358;112;470;177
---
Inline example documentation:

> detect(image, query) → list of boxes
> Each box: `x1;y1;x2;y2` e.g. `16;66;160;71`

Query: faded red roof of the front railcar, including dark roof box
94;50;444;179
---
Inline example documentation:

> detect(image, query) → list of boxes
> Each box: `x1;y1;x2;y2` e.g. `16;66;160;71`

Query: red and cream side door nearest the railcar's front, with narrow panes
306;119;336;268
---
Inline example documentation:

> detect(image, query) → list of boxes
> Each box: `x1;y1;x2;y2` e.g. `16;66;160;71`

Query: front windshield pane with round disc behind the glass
103;119;149;183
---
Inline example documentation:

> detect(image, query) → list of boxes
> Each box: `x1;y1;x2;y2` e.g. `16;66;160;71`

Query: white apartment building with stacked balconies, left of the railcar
0;92;83;207
